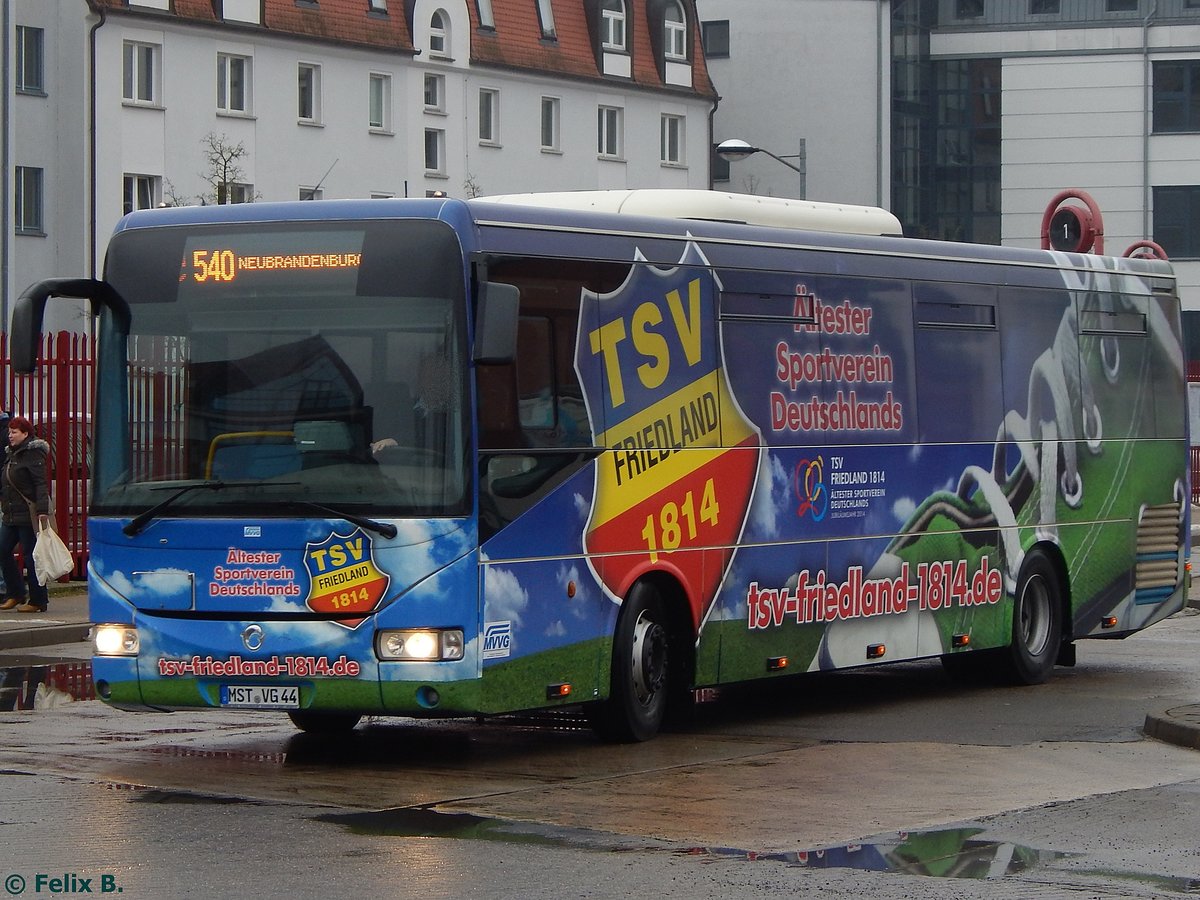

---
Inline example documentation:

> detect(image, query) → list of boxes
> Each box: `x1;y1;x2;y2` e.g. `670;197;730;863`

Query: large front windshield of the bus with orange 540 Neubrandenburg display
92;221;468;516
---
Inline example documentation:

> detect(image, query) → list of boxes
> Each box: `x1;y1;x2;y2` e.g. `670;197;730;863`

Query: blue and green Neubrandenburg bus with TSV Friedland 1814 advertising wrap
12;191;1190;742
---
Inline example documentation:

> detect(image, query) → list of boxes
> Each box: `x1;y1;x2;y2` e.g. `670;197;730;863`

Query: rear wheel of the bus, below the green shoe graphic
1003;550;1062;684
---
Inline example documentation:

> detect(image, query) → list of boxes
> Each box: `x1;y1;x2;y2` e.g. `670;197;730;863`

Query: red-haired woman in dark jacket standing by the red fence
0;415;50;612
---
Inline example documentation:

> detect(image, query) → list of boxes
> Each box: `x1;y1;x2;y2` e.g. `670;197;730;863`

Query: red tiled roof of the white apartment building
90;0;716;97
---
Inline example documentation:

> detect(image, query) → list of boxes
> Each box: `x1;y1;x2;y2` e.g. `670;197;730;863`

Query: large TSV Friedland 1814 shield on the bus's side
575;241;761;623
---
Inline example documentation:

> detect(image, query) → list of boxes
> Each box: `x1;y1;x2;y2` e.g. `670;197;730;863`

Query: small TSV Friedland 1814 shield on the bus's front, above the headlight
304;528;390;629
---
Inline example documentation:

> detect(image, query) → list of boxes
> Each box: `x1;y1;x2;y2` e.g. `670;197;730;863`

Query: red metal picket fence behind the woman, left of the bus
0;331;95;578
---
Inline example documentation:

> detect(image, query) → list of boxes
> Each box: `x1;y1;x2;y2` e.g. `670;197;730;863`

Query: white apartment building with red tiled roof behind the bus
0;0;716;329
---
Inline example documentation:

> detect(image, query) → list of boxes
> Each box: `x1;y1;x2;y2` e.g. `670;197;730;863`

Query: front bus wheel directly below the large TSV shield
592;582;672;743
